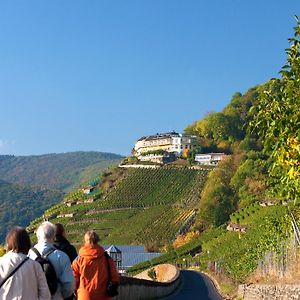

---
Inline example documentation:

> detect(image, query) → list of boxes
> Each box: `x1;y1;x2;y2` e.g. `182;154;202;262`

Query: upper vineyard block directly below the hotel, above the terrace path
102;168;207;207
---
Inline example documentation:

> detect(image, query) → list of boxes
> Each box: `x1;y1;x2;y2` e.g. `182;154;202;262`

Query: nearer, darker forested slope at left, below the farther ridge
0;180;63;243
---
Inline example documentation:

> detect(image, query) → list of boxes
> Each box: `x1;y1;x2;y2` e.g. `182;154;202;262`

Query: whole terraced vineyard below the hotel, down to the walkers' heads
30;167;208;249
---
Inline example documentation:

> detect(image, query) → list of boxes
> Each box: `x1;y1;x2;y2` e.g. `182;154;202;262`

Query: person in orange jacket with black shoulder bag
72;230;120;300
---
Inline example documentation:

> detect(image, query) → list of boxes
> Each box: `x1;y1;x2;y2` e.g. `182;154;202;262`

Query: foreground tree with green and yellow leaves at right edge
251;17;300;203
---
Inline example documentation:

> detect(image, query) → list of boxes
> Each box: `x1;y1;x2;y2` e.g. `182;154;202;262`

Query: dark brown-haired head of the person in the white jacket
6;226;31;255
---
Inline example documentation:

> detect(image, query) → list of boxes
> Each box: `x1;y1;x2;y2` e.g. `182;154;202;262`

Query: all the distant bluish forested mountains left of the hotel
0;151;123;243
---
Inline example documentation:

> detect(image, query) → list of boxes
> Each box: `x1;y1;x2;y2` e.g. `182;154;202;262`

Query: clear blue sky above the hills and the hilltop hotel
0;0;300;155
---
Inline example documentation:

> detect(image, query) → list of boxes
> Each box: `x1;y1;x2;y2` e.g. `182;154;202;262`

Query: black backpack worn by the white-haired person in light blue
31;247;58;295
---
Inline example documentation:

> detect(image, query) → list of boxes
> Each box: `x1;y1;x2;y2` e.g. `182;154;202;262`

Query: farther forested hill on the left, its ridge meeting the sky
0;151;122;195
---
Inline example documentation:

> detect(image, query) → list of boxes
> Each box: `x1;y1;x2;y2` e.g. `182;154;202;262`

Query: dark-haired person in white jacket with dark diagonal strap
0;227;51;300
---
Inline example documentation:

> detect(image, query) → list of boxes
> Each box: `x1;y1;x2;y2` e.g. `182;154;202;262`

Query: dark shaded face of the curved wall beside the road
114;274;181;300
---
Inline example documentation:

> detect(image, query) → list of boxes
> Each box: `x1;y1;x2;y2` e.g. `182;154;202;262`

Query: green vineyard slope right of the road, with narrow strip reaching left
129;204;300;283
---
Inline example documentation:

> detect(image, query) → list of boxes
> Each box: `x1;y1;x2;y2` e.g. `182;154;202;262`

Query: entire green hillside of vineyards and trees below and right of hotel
24;20;300;295
